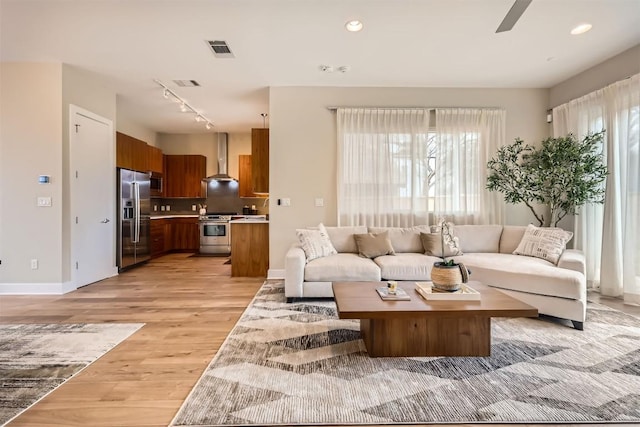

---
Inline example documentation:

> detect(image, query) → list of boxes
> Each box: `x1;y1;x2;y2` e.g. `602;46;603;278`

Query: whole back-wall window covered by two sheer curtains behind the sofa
338;109;504;226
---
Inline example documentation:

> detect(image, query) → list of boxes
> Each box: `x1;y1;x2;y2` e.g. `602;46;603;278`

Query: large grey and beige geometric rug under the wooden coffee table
171;280;640;426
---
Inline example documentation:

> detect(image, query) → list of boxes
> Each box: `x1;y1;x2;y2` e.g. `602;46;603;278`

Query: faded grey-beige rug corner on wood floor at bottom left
0;323;144;425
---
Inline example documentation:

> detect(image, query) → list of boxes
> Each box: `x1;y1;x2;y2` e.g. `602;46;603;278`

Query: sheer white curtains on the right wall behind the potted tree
554;74;640;303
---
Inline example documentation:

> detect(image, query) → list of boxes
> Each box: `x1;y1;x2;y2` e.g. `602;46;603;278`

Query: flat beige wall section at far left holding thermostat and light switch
0;63;64;283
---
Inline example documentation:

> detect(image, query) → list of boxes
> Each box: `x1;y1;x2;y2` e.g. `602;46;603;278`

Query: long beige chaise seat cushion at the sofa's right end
450;253;586;299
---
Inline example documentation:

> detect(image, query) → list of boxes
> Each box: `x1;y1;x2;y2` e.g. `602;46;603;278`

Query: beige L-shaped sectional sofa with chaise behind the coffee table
285;225;586;330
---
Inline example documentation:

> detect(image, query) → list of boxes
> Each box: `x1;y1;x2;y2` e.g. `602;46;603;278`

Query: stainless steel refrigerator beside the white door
117;169;151;271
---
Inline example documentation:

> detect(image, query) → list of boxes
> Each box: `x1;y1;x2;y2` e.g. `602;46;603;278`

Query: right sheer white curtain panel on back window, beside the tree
434;108;506;224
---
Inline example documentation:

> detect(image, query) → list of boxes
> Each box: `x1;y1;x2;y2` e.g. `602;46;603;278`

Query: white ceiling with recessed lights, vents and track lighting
0;0;640;133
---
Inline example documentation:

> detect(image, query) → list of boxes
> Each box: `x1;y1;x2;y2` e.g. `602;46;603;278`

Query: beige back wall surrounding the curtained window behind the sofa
269;87;550;269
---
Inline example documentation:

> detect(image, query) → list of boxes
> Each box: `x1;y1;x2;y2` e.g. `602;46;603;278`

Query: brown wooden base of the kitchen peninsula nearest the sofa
231;222;269;277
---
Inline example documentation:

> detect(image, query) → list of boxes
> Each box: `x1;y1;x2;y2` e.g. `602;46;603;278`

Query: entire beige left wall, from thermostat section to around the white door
0;63;116;292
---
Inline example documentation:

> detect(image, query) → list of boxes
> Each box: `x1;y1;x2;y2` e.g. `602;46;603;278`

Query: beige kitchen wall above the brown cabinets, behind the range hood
156;133;251;178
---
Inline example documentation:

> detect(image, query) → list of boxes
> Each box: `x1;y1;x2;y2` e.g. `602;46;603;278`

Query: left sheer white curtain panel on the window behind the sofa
337;108;429;227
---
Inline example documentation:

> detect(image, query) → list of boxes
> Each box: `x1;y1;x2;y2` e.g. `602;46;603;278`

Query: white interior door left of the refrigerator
69;105;117;287
